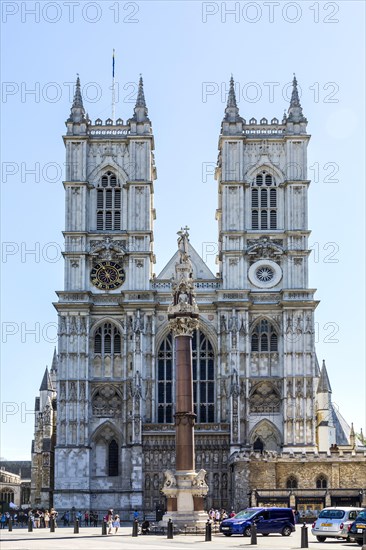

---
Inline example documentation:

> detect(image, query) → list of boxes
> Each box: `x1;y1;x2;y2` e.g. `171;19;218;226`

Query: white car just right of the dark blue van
311;506;363;542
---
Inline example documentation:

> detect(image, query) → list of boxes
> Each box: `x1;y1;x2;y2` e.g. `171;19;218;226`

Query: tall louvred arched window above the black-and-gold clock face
97;172;121;231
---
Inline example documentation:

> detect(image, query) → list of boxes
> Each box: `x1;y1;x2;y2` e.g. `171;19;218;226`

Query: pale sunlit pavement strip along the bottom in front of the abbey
0;527;361;550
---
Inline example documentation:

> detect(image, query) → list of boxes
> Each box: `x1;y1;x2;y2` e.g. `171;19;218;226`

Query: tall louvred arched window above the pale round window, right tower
251;171;277;229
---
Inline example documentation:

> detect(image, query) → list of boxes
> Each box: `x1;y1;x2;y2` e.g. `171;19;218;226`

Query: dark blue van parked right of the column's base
220;508;295;537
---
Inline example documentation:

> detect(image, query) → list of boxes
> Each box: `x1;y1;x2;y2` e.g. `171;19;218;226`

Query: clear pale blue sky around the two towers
0;0;365;460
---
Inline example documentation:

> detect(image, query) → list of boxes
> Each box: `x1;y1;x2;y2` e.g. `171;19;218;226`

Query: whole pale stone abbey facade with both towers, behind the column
32;78;335;515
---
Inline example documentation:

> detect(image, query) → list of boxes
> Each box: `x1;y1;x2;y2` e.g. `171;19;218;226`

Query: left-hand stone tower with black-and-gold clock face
54;77;156;511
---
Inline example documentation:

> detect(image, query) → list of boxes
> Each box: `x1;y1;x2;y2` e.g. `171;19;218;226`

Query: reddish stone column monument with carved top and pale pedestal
162;227;208;527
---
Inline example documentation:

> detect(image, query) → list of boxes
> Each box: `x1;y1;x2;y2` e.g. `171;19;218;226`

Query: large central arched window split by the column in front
157;330;215;423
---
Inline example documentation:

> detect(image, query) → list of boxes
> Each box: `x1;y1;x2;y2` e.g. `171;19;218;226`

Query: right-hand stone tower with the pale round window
216;77;318;508
